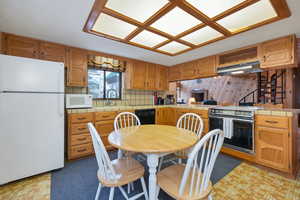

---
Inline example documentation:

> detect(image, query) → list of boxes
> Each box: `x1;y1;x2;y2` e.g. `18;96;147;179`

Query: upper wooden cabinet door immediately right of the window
131;62;147;90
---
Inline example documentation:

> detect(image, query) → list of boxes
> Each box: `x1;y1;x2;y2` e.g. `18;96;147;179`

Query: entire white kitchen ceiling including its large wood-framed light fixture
0;0;300;66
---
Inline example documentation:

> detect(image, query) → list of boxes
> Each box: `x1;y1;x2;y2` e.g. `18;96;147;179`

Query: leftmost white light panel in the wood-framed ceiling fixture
92;13;137;39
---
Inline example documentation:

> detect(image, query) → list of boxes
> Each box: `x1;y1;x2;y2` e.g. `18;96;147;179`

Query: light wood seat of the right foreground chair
157;164;212;200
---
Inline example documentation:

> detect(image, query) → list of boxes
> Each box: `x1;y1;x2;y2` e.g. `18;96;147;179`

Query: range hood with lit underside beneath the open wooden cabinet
217;61;263;75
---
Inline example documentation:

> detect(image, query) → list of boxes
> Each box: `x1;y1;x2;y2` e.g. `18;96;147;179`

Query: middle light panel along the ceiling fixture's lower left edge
130;30;167;47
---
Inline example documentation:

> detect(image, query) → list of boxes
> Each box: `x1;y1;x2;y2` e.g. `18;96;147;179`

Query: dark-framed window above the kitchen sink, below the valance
88;68;122;99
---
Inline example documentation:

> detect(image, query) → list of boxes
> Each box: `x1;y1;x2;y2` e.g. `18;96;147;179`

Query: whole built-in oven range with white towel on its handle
209;106;260;154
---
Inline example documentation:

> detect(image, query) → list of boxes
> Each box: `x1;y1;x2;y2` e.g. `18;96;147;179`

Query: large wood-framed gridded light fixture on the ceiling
84;0;291;56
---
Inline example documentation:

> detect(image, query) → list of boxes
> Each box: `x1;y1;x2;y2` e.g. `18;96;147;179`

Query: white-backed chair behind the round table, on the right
158;113;204;170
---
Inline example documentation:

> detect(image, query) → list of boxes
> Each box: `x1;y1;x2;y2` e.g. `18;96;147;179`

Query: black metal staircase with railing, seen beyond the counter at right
239;70;286;105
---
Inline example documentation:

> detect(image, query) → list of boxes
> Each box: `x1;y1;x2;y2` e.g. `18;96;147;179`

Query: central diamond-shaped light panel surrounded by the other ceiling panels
151;7;202;36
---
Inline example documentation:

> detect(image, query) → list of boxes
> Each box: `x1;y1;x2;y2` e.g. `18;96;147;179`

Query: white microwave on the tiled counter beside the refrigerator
66;94;93;108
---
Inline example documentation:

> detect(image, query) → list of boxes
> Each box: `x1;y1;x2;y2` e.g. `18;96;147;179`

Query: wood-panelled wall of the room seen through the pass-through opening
179;74;257;104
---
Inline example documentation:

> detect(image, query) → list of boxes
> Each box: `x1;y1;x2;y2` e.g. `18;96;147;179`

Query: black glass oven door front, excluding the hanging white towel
209;116;254;153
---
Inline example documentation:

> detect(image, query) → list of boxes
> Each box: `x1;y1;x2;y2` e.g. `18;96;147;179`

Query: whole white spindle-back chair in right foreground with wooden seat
157;129;224;200
